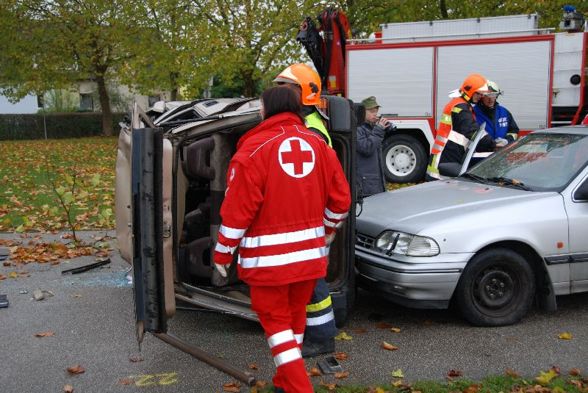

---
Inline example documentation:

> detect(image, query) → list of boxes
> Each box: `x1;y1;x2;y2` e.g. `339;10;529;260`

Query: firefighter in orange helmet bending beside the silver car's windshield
427;74;495;180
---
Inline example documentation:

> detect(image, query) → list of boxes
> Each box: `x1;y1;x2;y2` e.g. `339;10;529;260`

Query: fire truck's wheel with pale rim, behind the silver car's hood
382;135;428;183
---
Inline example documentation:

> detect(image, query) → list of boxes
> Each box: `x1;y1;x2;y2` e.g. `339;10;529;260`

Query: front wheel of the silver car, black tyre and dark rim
455;248;535;326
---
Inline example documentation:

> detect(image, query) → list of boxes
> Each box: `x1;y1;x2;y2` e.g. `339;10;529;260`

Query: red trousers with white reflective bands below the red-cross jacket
250;280;316;393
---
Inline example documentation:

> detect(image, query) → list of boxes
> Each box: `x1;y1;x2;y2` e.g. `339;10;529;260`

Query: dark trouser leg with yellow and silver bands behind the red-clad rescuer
302;279;337;357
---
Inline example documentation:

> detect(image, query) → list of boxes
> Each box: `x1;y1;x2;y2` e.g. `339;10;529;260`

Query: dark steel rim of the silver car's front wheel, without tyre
474;268;515;308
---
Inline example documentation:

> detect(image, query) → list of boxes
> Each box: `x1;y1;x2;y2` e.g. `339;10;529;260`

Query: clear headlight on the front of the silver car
374;231;439;257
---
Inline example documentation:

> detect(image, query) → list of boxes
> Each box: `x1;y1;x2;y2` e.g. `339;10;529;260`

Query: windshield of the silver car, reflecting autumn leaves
468;133;588;192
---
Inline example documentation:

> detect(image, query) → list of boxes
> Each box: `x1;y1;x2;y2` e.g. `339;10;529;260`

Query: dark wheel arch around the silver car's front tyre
452;240;557;311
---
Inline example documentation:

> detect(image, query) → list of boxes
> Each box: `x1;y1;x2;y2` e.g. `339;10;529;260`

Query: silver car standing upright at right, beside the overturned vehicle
355;126;588;326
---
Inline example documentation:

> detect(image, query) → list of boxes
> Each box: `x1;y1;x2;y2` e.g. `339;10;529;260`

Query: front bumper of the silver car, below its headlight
355;248;470;308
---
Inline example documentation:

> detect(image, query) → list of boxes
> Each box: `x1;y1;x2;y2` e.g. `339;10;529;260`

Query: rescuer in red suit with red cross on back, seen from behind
214;86;351;393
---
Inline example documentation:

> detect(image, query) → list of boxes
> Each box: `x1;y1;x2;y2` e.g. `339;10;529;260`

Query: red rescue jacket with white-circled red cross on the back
214;113;351;286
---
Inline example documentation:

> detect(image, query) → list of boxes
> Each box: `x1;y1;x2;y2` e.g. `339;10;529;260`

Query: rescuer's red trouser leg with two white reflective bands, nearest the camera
250;285;313;393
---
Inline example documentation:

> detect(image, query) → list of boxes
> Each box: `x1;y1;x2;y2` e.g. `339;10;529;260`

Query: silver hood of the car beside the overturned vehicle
357;179;559;236
